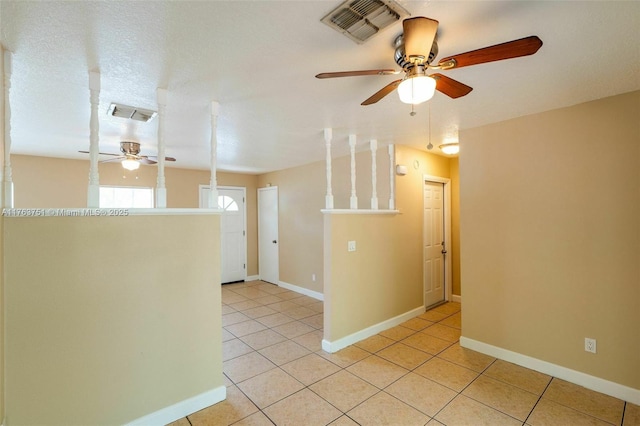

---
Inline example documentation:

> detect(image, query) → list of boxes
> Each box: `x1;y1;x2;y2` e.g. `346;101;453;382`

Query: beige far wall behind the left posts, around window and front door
11;155;258;276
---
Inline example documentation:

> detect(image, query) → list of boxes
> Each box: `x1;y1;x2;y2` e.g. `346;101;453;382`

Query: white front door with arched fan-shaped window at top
200;185;247;284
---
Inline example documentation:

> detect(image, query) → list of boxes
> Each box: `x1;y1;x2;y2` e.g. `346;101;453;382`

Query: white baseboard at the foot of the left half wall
125;386;227;426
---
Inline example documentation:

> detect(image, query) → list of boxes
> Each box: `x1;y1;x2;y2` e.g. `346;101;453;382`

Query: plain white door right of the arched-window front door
258;186;280;284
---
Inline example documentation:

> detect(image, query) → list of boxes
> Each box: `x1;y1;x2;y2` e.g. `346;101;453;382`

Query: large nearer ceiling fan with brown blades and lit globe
316;16;542;105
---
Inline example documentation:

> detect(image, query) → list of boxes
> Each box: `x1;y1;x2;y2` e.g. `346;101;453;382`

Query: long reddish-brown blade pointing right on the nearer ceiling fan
438;36;542;68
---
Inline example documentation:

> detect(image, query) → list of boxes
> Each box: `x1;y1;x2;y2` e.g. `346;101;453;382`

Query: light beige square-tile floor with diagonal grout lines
172;281;640;426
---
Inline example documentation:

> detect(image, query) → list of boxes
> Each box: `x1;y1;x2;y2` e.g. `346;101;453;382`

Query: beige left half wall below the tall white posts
4;215;224;425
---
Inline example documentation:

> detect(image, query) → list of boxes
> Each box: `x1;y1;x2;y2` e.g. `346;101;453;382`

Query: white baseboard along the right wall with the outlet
460;336;640;405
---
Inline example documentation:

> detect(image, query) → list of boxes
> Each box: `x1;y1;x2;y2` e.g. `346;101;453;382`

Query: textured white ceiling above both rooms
0;0;640;173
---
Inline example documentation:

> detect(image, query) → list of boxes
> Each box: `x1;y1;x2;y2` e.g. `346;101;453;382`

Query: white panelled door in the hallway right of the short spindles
423;181;445;308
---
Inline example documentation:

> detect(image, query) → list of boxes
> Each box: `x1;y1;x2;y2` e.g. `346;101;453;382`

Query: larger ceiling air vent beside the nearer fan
322;0;409;44
